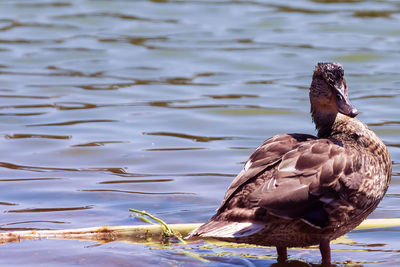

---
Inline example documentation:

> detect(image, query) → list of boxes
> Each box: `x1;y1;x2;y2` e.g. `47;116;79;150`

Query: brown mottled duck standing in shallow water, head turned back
187;62;392;266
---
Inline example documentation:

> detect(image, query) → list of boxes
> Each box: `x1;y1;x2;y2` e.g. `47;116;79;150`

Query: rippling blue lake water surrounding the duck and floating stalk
0;0;400;266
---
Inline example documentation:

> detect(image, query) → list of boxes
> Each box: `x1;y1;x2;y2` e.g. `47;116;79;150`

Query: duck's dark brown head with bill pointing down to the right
310;62;358;134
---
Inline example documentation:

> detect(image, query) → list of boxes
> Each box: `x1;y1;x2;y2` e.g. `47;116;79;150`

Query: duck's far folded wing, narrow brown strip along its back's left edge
218;134;316;214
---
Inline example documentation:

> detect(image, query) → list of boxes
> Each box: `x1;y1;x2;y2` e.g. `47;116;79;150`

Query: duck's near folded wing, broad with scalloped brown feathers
248;139;360;227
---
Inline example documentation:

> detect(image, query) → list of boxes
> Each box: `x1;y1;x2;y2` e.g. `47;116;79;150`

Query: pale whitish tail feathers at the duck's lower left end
186;221;264;239
